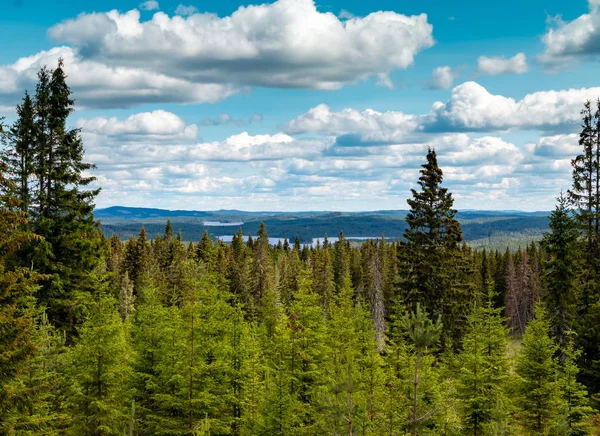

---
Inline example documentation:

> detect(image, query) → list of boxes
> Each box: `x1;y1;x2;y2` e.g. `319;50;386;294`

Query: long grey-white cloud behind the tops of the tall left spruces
0;47;241;108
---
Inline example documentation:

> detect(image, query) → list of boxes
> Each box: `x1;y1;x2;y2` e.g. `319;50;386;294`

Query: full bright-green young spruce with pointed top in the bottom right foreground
517;304;563;435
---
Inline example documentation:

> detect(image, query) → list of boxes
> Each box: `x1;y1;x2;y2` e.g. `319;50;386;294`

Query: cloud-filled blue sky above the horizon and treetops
0;0;600;211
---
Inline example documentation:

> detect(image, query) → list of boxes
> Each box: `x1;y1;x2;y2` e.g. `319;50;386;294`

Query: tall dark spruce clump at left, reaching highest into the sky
9;60;101;333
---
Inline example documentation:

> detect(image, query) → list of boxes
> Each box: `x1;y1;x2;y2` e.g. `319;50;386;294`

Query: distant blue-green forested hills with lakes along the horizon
95;206;550;249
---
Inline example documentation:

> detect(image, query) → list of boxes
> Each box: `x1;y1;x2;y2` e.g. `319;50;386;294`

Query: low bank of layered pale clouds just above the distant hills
83;106;578;209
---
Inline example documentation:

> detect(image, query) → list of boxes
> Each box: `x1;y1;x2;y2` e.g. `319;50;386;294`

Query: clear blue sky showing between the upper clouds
0;0;597;140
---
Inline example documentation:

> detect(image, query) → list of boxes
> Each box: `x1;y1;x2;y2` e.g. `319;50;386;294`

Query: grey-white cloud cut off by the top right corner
538;0;600;67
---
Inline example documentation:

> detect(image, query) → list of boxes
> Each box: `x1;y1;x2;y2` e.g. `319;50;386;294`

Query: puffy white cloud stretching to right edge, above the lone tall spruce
284;82;600;137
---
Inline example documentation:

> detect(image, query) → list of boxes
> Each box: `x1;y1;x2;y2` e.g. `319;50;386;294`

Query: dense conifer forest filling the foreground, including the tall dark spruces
0;62;600;436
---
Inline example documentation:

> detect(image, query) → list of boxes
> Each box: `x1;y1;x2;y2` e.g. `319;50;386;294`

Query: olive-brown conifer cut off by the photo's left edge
0;162;54;434
